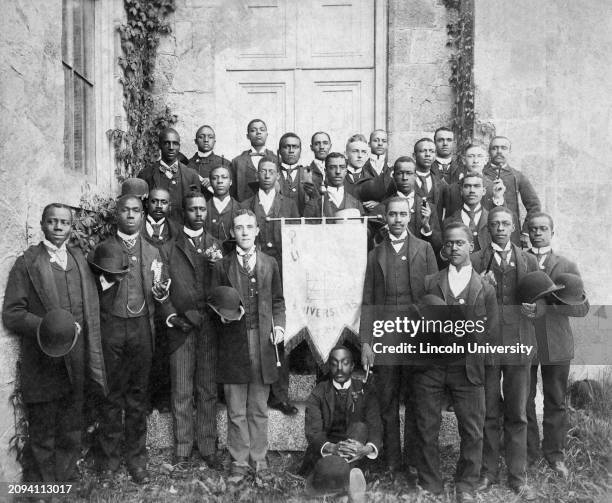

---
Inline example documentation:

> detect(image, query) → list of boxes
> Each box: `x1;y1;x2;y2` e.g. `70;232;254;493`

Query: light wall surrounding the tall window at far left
0;0;123;482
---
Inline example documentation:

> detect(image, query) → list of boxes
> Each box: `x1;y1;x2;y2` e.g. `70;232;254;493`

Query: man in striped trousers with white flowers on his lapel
161;192;225;469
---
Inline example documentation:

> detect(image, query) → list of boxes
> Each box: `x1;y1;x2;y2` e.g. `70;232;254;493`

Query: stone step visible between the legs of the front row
147;401;457;451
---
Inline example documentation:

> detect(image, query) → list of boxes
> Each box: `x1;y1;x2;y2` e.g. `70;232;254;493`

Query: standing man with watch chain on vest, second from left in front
93;196;169;484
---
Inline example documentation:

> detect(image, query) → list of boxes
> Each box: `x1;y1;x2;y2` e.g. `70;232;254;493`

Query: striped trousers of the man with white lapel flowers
170;321;217;456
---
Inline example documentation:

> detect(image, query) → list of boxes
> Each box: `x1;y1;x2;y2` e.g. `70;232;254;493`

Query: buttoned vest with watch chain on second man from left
111;237;148;318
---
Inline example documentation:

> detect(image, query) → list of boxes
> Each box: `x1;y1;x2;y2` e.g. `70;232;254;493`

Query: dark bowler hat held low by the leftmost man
36;309;78;358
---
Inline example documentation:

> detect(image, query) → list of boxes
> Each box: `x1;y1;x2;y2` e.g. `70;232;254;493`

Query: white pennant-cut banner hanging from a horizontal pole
282;220;367;362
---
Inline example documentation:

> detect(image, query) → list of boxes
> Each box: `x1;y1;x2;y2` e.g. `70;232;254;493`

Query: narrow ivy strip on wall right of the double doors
444;0;475;149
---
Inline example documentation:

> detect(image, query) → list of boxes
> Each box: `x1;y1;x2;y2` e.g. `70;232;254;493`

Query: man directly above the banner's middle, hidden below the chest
304;152;363;217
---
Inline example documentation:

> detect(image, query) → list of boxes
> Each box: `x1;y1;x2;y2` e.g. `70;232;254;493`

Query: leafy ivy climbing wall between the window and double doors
108;0;177;182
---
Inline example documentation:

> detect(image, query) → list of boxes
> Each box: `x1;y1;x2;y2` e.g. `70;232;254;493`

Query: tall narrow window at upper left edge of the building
62;0;95;175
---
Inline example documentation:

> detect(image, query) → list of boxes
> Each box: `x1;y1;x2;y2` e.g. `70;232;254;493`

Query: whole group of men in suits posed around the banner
3;119;588;501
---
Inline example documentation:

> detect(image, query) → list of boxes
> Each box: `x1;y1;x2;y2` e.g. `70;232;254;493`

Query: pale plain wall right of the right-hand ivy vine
474;0;612;370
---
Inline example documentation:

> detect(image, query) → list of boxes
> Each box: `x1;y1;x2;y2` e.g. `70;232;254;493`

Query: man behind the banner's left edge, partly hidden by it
242;159;299;415
